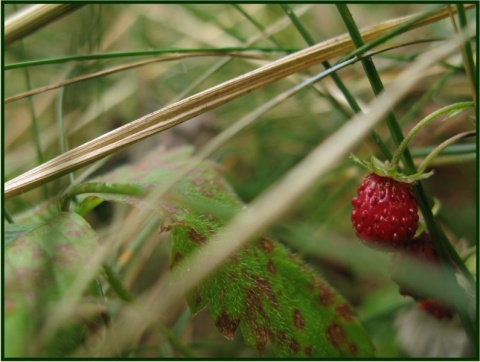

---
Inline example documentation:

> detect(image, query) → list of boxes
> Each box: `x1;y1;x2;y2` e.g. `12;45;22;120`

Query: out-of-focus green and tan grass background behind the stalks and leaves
3;3;477;357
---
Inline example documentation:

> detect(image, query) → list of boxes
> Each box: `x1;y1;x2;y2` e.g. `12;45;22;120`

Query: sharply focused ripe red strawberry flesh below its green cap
351;173;418;247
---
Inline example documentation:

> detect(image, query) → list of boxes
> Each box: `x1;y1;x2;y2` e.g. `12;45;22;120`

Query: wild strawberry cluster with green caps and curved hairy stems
351;99;473;330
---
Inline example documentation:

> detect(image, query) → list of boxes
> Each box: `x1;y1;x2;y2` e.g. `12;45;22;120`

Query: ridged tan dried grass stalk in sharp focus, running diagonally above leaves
5;4;472;199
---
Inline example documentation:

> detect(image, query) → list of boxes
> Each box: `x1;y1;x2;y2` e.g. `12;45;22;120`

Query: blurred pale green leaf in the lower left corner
4;213;101;357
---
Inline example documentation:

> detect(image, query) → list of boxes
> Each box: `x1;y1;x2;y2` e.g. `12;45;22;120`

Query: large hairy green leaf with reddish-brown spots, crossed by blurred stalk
72;149;373;357
